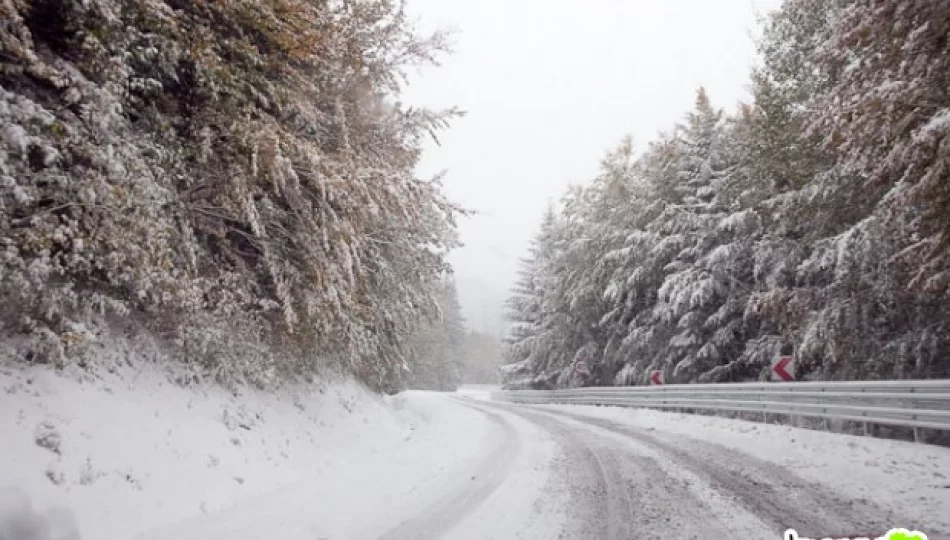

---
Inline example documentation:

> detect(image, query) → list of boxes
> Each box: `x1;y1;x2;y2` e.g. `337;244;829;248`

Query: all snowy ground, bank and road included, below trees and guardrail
0;365;950;540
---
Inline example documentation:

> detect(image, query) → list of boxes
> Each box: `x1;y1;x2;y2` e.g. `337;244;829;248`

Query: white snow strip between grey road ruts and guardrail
541;405;950;538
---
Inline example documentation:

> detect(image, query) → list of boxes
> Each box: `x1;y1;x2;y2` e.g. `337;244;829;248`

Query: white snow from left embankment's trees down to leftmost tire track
0;364;532;540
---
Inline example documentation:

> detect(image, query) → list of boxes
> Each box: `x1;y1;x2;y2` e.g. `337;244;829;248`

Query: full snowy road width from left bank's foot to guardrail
162;393;950;540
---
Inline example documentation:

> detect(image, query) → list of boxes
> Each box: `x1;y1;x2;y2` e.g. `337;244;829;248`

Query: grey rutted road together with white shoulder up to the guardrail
432;392;950;539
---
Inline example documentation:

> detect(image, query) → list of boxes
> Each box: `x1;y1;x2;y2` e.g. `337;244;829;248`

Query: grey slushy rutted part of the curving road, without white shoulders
454;400;928;540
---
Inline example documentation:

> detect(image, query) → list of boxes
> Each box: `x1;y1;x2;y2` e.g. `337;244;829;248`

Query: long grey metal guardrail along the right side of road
492;379;950;438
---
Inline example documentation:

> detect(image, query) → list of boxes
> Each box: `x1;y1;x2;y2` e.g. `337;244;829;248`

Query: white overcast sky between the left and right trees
404;0;781;333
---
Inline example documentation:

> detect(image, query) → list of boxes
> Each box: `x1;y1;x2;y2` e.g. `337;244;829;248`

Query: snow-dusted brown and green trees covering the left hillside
0;0;457;389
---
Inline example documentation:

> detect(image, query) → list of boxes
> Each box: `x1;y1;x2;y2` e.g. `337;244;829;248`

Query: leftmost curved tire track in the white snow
379;400;522;540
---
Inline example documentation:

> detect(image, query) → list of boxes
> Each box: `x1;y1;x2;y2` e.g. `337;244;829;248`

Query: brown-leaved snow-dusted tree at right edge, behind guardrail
802;1;950;377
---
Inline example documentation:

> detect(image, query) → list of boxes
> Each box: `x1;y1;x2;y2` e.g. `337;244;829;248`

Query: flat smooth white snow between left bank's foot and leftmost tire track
145;392;494;540
